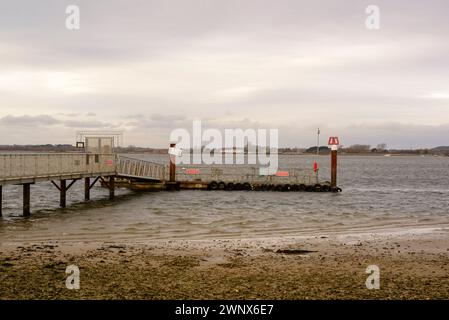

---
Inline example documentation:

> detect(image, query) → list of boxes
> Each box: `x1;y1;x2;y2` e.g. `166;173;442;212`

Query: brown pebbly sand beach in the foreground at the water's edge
0;228;449;299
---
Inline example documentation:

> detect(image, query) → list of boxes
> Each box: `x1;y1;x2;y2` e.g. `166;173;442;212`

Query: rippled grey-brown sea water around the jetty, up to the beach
0;155;449;242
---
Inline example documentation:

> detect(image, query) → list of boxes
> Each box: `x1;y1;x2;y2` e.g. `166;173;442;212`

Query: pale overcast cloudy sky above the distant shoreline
0;0;449;148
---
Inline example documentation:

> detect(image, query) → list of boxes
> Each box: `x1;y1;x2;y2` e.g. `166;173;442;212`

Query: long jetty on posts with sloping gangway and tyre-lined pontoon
0;151;341;216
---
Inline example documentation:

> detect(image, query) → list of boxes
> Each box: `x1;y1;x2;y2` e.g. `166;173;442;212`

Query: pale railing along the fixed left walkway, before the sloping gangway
0;153;116;184
